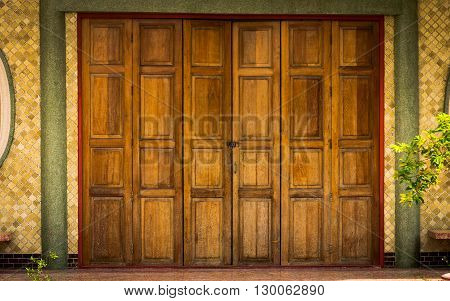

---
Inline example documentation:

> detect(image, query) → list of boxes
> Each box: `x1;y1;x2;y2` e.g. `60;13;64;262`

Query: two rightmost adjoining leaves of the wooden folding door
281;21;379;265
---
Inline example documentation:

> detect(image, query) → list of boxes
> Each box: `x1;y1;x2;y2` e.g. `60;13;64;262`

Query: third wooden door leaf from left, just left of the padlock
184;20;232;265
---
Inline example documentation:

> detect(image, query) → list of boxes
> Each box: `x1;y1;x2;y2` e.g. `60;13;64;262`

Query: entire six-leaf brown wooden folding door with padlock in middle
80;19;379;266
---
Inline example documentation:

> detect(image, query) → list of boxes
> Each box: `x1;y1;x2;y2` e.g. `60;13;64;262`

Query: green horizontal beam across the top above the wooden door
56;0;402;15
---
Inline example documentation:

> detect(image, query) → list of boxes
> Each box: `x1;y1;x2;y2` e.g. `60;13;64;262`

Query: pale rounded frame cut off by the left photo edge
0;49;16;167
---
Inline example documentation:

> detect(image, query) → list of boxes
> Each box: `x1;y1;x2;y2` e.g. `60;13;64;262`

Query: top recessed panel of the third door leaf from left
191;26;224;67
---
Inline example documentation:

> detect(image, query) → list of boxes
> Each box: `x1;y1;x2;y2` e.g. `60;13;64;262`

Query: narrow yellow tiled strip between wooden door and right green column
384;17;395;252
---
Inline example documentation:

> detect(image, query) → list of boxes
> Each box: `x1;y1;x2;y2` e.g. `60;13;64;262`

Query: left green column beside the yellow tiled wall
40;0;67;268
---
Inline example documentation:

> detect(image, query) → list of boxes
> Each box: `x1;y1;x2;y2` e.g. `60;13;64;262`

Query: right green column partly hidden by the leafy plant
394;0;420;268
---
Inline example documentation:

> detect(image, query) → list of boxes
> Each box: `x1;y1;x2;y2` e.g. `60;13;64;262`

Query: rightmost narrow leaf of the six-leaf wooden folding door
331;22;380;264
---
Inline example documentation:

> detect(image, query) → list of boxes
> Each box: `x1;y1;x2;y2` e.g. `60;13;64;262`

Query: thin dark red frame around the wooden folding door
77;13;385;268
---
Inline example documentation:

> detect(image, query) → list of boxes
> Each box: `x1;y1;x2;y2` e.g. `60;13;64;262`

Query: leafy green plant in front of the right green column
391;113;450;206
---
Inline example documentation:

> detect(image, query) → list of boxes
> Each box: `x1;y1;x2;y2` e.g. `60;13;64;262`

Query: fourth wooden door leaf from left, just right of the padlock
233;22;280;264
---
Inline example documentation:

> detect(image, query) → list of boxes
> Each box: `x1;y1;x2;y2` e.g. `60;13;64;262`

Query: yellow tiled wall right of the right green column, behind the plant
419;0;450;252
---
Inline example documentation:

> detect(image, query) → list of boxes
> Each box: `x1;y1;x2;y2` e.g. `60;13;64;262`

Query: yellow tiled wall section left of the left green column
0;0;41;253
